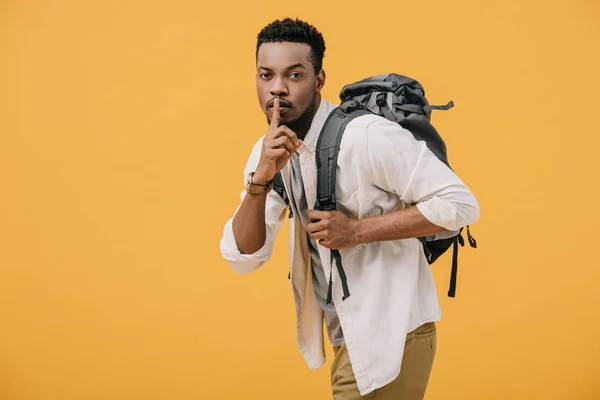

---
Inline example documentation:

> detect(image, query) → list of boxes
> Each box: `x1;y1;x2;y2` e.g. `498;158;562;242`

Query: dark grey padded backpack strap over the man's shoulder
314;101;372;211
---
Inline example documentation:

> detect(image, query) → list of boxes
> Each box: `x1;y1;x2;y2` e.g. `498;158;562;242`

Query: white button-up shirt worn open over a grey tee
221;100;479;396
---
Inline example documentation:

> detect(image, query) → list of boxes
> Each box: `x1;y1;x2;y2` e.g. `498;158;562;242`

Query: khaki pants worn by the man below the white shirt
331;322;436;400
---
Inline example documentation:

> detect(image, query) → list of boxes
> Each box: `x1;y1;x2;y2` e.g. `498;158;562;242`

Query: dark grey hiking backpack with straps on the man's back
273;74;477;304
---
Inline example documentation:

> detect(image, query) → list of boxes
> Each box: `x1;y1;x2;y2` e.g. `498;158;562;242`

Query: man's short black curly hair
256;18;325;74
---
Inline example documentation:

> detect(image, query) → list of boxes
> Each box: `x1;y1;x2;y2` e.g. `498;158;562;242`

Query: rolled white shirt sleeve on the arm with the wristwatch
220;138;287;274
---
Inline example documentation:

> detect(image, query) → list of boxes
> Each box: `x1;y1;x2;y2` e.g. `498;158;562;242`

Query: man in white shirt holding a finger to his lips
221;19;479;400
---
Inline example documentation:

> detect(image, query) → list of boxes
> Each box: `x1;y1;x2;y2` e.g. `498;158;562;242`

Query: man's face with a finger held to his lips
256;42;325;130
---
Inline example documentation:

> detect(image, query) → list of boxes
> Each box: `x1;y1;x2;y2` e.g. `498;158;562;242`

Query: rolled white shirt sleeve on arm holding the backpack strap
367;118;479;231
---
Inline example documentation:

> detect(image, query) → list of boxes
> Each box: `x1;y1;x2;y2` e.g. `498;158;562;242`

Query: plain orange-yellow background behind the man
0;0;600;400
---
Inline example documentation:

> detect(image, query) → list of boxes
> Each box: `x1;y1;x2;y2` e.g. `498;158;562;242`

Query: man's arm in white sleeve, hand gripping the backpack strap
309;120;479;249
